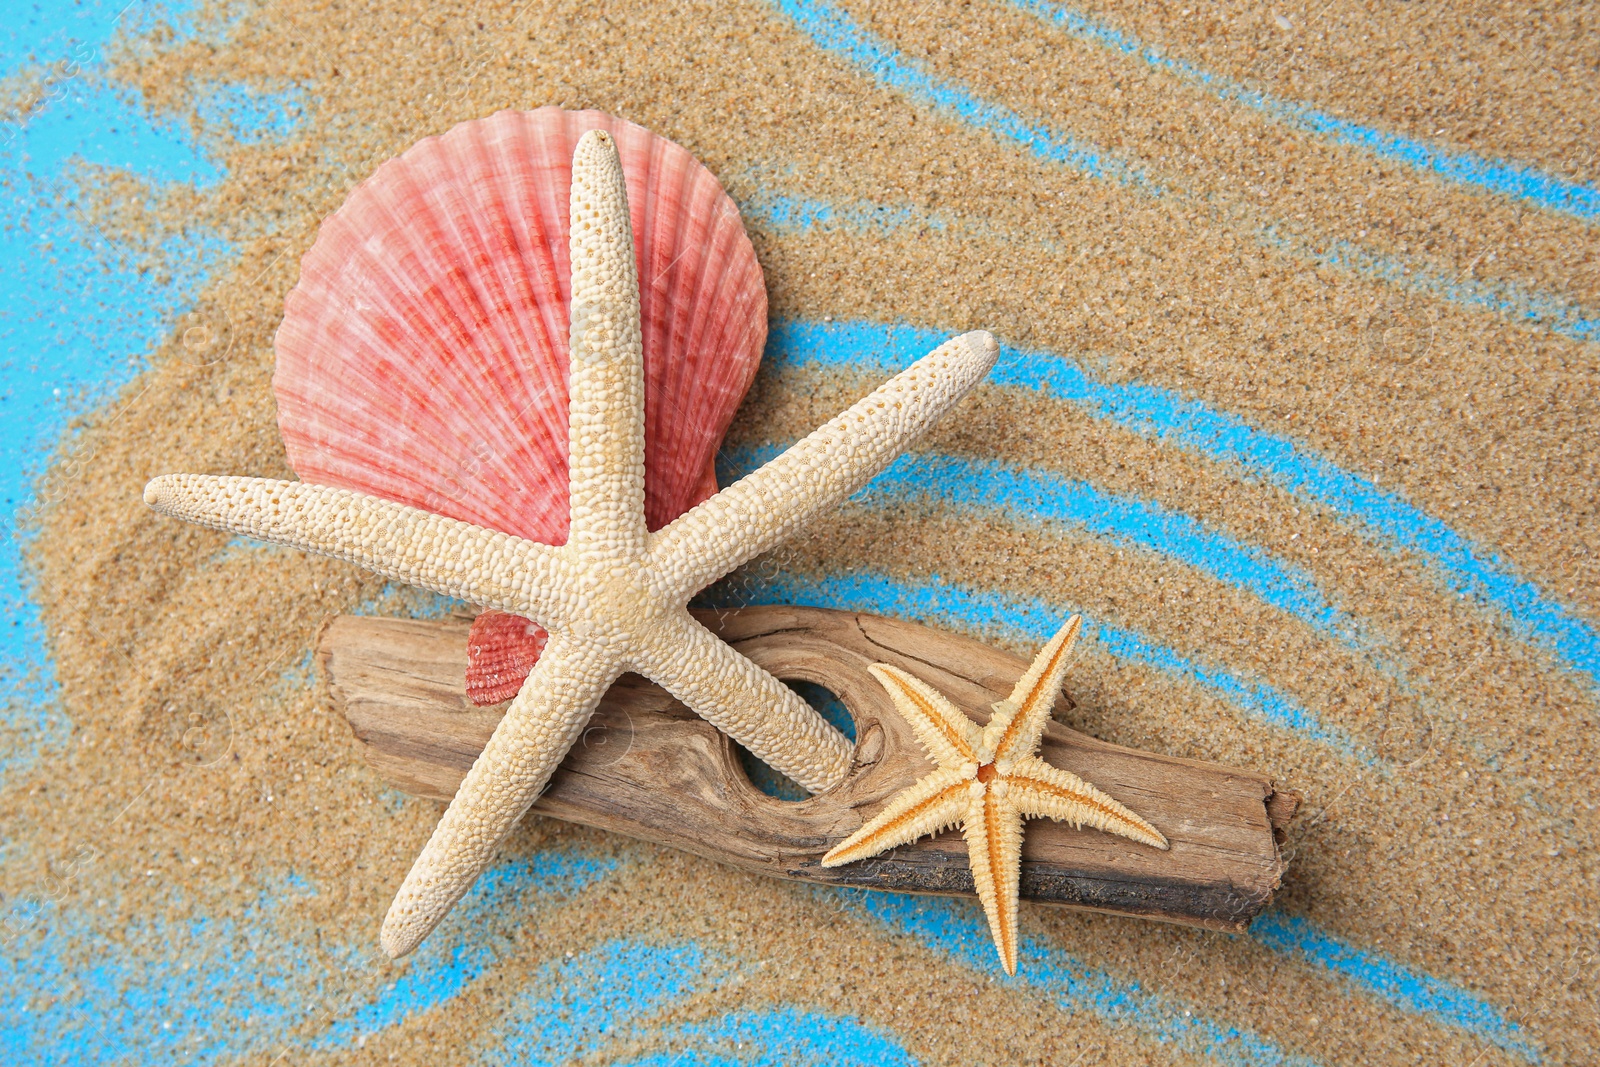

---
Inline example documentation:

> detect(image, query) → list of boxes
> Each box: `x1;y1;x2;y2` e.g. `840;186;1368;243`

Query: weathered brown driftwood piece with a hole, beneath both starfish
317;606;1299;931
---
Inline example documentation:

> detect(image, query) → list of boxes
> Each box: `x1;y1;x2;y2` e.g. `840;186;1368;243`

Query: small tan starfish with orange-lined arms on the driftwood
822;616;1166;974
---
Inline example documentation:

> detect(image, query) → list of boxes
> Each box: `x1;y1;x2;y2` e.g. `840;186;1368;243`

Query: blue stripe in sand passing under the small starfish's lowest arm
851;889;1314;1067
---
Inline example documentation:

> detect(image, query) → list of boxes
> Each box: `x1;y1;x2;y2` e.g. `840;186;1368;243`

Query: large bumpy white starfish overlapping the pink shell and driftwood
144;130;998;957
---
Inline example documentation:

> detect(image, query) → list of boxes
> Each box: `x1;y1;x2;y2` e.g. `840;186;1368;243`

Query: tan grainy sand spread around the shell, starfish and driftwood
12;0;1600;1064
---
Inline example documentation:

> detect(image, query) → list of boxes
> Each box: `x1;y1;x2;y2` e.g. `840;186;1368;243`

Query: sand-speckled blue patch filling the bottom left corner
0;853;614;1067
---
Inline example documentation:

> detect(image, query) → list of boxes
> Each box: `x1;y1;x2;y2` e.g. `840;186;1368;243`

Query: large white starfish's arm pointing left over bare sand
144;474;566;625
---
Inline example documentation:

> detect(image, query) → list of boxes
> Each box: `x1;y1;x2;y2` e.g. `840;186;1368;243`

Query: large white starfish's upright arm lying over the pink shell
566;130;646;557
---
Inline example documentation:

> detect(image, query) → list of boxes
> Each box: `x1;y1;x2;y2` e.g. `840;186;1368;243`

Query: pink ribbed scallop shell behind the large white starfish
272;107;766;704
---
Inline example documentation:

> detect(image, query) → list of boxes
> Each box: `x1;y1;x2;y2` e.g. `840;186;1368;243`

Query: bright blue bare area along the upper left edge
0;0;243;773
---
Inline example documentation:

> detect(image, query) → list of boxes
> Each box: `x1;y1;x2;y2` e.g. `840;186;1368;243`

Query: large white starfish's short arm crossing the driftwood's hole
632;611;854;793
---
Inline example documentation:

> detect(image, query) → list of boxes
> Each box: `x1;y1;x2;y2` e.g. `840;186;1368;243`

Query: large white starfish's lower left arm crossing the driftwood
382;633;622;957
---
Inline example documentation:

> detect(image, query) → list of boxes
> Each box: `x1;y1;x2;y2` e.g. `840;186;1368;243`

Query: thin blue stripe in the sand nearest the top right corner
1011;0;1600;221
